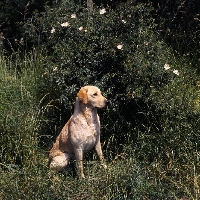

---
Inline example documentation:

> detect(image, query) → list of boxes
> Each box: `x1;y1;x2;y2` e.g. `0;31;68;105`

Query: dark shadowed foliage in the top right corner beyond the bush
152;0;200;72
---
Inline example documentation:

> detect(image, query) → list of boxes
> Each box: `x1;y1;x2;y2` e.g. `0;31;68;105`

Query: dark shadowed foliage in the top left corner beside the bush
0;0;53;53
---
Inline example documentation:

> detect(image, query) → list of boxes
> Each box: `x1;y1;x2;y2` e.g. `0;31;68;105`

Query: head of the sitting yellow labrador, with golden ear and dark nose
77;86;108;108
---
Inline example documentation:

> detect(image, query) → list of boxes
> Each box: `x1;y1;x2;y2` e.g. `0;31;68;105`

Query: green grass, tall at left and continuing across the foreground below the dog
0;49;200;200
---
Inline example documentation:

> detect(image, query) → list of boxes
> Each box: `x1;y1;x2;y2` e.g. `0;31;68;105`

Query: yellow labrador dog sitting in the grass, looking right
49;86;108;178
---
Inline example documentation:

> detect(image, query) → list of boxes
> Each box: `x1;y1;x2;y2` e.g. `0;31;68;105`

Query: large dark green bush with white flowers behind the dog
25;1;196;160
